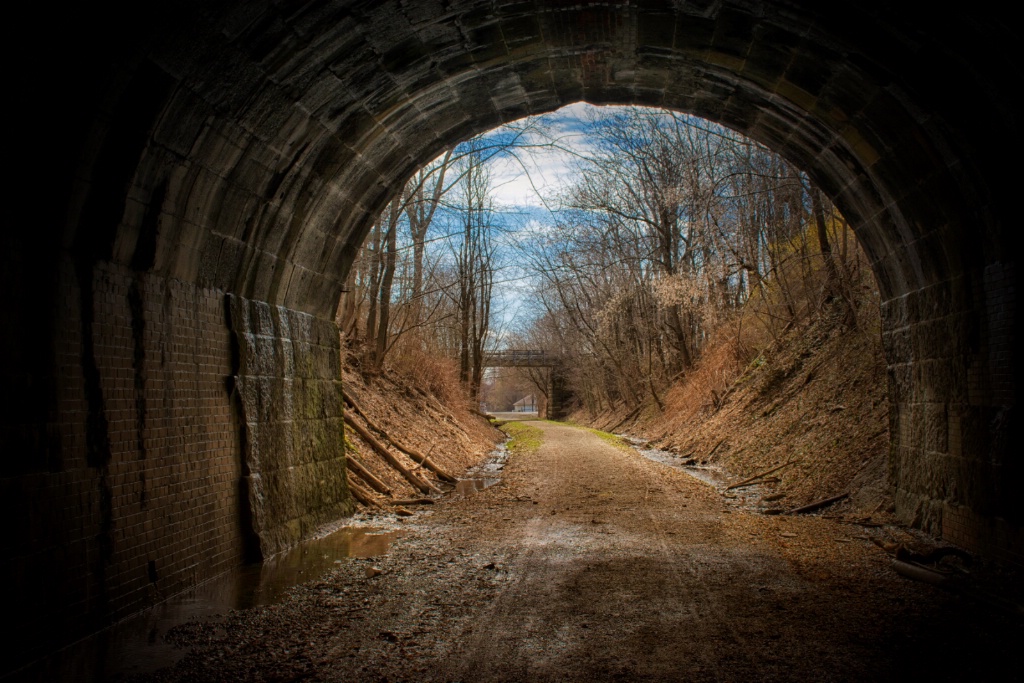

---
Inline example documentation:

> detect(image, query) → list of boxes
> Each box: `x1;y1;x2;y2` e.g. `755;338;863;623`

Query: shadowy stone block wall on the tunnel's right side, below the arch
882;264;1024;566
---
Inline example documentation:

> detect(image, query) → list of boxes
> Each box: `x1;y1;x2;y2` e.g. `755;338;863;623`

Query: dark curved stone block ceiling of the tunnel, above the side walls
32;0;1020;316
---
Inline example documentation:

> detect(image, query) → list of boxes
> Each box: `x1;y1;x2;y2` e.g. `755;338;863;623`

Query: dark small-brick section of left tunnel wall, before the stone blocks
0;262;246;671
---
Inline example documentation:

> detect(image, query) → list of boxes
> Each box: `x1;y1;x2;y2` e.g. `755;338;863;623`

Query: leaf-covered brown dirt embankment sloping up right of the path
573;309;892;519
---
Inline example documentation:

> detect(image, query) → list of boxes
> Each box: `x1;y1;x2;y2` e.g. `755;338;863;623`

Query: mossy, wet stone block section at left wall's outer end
228;296;352;556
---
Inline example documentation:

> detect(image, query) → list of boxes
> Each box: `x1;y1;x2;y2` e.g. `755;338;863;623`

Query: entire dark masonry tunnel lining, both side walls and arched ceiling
0;0;1024;664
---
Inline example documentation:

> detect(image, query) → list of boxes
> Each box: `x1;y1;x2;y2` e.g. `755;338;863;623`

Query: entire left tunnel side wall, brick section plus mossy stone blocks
0;260;351;673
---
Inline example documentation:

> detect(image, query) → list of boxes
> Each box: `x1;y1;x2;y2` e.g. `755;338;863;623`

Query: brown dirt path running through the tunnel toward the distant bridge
138;423;1024;681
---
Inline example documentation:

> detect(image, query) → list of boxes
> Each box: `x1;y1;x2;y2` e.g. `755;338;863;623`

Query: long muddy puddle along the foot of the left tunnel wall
15;526;403;681
